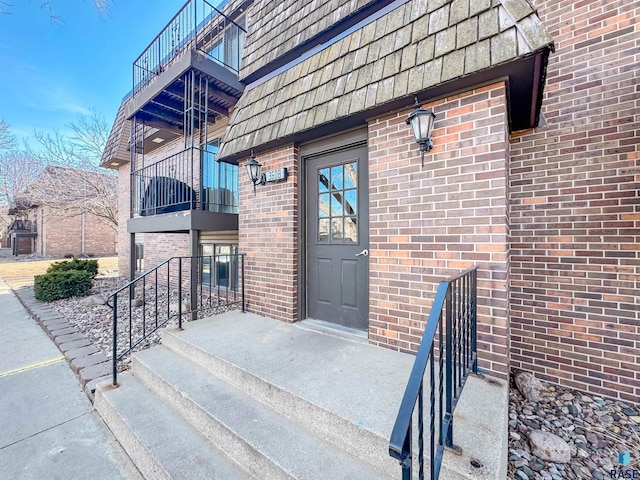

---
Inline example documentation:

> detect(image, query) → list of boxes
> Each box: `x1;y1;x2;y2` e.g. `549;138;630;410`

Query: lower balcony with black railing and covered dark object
127;147;238;233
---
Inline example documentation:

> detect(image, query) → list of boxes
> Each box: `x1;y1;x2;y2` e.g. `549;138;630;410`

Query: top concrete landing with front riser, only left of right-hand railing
161;312;404;478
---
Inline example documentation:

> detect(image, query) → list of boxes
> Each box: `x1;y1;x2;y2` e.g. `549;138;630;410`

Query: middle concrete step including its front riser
132;347;388;480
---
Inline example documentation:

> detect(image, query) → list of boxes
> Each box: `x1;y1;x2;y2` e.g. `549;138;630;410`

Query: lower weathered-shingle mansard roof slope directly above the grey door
219;0;553;159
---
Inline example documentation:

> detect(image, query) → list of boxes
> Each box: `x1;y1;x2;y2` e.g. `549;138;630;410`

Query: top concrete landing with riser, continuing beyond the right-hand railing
161;312;508;480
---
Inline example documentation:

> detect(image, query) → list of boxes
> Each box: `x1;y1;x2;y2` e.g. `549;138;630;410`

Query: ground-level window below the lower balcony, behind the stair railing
200;243;238;290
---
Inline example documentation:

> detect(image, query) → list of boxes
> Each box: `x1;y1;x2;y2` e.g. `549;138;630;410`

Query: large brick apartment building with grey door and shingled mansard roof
103;0;640;401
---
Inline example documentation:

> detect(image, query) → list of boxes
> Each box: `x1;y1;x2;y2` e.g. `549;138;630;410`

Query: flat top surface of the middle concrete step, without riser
134;347;386;480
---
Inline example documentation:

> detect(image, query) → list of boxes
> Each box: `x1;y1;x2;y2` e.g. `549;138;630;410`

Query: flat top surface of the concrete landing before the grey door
163;311;415;439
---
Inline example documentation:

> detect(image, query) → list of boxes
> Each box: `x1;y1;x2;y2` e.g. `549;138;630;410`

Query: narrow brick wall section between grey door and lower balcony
238;146;298;322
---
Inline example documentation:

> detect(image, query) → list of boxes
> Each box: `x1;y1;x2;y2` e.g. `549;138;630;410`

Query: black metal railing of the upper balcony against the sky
133;0;245;95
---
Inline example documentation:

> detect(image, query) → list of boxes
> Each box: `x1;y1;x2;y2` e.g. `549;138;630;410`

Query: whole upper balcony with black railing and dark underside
127;0;245;131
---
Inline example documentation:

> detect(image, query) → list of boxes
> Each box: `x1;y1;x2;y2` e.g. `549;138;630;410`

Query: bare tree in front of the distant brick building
29;111;118;228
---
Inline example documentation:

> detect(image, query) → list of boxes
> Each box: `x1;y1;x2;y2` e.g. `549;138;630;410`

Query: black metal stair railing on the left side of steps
107;253;245;385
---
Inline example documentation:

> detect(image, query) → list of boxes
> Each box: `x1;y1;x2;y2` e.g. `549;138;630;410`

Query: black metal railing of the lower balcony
131;148;238;216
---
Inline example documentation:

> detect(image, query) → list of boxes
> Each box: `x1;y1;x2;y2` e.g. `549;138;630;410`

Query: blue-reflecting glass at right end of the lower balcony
201;140;238;213
